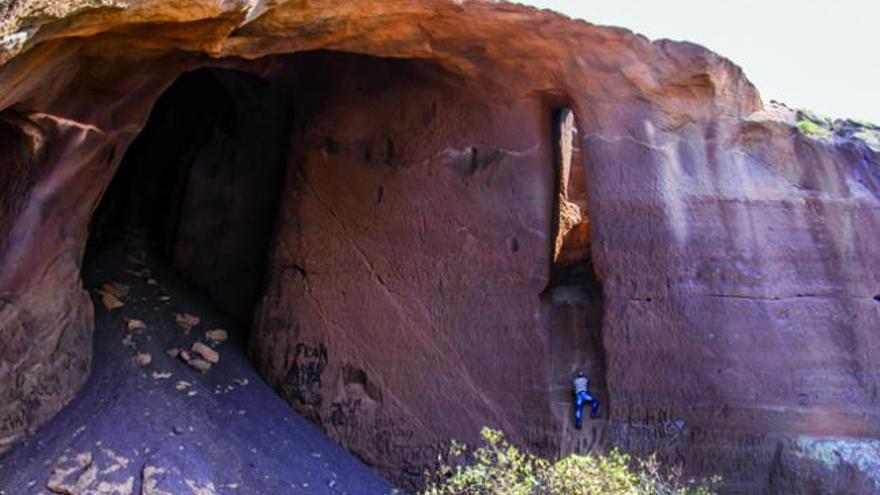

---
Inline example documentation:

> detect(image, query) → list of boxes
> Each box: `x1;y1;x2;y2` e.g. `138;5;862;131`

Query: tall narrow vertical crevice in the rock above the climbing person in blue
541;108;608;452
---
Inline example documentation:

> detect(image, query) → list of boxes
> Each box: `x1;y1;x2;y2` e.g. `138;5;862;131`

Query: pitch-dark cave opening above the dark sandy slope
86;68;293;328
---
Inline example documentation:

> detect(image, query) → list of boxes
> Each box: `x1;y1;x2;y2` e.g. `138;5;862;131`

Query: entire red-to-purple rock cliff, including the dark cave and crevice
0;0;880;493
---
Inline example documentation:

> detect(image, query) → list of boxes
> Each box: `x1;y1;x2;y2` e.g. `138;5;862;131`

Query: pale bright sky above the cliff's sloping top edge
520;0;880;124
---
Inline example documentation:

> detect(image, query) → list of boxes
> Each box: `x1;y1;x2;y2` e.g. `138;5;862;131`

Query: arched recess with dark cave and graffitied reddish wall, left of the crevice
77;51;603;486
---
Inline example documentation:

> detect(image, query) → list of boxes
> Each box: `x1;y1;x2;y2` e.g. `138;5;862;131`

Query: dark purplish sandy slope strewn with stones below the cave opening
0;238;392;495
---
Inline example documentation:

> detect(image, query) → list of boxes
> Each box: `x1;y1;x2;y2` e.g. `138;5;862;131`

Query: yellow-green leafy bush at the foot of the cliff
422;428;720;495
